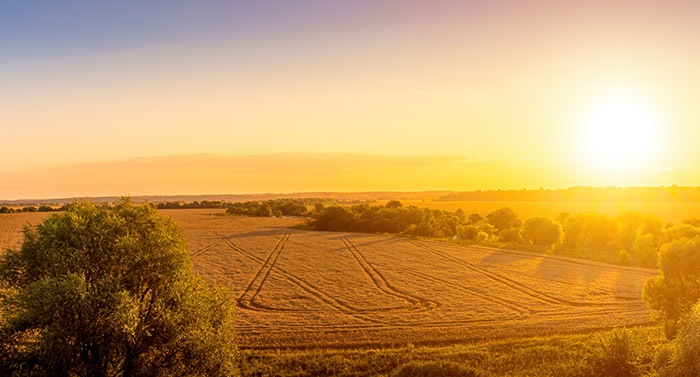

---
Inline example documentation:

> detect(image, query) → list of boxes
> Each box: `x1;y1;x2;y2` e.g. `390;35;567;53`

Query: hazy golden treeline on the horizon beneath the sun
438;186;700;203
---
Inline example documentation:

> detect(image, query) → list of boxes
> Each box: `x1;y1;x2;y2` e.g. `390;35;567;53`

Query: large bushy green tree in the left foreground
0;198;238;377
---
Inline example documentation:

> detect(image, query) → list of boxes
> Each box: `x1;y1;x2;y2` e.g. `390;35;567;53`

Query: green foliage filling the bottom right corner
656;303;700;377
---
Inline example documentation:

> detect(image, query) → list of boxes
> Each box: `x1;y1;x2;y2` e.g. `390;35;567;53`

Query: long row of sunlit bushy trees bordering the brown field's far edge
311;201;700;267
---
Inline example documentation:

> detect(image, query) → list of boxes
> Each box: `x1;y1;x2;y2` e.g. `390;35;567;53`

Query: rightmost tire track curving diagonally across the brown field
407;240;636;307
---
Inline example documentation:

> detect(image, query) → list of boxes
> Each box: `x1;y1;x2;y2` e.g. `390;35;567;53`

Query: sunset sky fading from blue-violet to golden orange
0;0;700;199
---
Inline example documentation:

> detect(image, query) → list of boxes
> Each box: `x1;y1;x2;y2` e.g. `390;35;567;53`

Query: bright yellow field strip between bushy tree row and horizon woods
402;200;700;223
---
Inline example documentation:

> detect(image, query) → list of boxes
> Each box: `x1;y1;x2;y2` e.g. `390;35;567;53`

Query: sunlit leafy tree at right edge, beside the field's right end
642;237;700;337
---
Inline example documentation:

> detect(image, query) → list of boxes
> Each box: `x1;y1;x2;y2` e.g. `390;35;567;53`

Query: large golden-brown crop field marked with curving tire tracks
0;210;656;348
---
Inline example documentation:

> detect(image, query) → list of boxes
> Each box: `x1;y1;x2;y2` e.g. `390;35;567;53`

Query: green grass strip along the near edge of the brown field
241;327;664;377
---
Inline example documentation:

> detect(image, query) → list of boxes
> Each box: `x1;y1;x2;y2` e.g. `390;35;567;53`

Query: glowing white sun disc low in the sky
582;98;657;169
